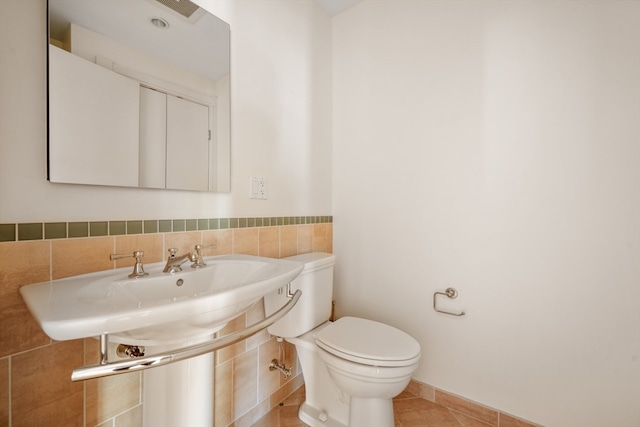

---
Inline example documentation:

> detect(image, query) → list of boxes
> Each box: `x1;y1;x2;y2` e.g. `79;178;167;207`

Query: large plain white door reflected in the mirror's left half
49;45;140;186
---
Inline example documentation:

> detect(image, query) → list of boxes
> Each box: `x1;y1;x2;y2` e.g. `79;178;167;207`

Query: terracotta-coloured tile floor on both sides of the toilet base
252;386;490;427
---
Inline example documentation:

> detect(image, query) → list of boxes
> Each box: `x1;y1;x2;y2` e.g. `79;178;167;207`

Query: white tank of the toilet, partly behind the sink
264;252;336;338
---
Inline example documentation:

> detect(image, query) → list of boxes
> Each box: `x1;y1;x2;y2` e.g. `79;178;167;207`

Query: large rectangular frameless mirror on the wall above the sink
48;0;231;191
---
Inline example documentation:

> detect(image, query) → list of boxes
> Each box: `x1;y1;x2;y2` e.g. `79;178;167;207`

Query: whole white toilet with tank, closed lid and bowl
264;252;420;427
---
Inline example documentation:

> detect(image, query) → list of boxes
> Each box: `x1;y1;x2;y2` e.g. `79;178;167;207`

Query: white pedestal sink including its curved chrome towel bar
20;255;303;426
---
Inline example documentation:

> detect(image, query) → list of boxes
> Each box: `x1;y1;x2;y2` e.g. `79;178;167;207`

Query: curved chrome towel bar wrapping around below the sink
71;289;302;381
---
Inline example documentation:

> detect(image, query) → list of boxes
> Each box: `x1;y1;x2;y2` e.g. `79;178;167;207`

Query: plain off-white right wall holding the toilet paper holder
333;0;640;426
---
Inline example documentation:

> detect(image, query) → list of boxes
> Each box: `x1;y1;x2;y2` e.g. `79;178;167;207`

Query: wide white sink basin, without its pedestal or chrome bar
20;255;303;345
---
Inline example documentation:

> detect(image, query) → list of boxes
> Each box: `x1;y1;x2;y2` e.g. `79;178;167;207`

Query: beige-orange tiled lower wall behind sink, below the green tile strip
0;223;333;427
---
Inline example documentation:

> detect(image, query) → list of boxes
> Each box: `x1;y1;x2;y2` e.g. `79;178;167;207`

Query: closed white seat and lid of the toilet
315;317;420;367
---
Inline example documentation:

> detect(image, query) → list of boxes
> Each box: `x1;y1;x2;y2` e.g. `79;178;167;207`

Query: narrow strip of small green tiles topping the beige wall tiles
0;215;333;243
